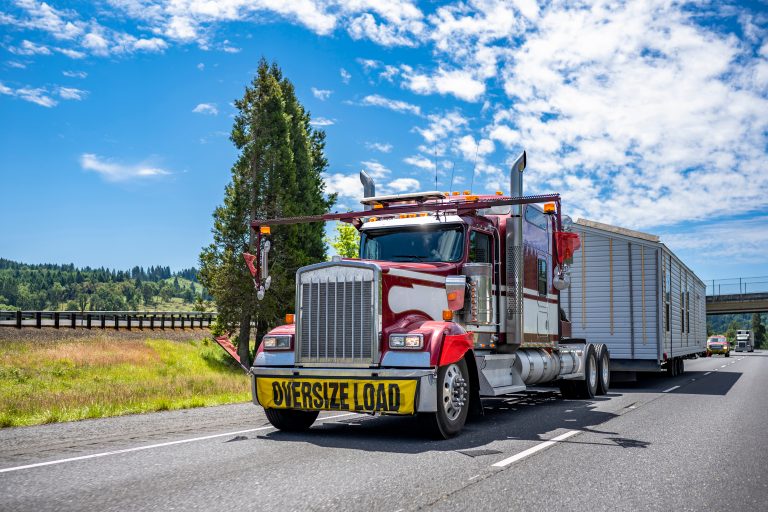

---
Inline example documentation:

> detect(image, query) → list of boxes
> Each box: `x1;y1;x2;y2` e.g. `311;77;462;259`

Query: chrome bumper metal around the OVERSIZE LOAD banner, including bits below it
250;366;437;414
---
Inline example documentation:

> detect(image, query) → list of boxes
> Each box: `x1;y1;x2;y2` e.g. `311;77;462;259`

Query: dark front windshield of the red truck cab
360;225;464;262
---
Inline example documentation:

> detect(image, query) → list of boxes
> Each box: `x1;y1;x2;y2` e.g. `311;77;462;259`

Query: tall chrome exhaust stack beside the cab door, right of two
504;151;526;349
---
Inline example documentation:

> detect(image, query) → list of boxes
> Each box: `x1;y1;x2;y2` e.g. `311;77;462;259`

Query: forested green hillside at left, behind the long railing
0;258;210;311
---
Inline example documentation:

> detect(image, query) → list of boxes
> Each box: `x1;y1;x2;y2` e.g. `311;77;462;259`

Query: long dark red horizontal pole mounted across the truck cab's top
251;194;560;229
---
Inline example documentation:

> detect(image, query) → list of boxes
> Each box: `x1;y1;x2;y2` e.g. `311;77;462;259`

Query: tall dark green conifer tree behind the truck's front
199;59;335;358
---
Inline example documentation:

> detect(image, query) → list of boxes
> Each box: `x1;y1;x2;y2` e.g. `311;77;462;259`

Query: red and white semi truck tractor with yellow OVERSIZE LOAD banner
217;153;610;438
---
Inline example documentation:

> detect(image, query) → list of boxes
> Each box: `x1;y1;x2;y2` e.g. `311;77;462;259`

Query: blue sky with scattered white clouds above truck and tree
0;0;768;279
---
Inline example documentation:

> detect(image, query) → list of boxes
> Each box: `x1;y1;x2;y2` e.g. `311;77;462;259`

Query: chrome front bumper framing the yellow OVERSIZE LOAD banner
250;366;437;412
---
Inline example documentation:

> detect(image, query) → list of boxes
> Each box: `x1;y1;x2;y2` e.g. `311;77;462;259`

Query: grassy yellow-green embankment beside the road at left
0;335;250;427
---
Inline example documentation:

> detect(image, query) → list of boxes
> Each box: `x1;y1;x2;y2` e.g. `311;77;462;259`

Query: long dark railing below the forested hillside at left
0;311;217;330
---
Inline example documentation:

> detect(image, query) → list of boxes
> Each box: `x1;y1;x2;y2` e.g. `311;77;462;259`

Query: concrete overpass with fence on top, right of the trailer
706;276;768;315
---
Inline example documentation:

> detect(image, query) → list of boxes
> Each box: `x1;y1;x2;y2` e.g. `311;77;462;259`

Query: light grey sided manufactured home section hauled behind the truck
561;224;706;368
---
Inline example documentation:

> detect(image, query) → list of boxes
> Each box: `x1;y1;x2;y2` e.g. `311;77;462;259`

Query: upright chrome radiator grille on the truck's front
296;262;379;366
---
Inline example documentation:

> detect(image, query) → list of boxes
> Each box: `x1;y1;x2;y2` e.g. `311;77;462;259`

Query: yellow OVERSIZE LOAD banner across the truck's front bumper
256;377;418;414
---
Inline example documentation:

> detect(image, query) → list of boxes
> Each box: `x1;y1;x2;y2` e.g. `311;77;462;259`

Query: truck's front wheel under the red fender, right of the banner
422;359;472;439
